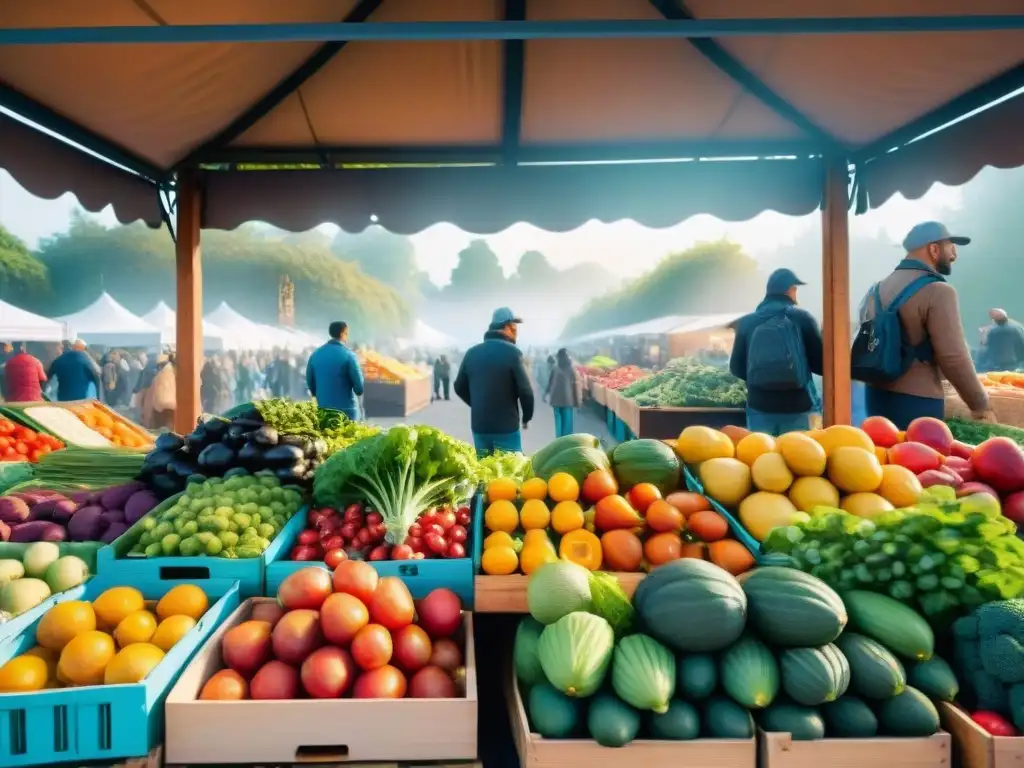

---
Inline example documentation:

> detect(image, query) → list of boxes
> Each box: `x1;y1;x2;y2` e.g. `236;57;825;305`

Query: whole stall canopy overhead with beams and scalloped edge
0;0;1024;228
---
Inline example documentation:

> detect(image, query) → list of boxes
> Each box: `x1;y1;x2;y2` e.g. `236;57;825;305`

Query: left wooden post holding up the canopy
174;172;203;434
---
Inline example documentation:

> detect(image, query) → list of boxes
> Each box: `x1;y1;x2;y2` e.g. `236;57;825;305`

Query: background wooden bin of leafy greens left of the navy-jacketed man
615;357;746;439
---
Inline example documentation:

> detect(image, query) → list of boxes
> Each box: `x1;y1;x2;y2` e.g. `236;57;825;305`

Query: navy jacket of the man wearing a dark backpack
729;294;822;414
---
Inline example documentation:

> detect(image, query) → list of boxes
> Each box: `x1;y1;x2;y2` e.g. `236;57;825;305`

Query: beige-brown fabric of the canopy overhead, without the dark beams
0;0;1024;231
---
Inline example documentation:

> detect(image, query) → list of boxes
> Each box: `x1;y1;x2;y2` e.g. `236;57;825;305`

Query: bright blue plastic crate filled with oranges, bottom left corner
0;578;239;766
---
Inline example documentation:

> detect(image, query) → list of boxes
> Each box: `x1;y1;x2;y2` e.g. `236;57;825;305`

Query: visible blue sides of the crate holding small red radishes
263;495;483;605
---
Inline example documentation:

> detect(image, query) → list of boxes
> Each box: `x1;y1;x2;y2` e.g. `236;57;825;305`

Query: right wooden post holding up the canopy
821;158;852;426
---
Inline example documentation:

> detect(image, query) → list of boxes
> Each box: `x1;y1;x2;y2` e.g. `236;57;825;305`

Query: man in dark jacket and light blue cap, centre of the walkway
455;307;534;456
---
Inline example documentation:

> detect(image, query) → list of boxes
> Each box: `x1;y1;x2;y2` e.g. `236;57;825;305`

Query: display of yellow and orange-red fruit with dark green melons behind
476;434;756;612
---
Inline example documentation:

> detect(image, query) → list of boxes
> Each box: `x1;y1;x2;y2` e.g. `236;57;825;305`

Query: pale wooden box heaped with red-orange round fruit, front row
165;560;477;765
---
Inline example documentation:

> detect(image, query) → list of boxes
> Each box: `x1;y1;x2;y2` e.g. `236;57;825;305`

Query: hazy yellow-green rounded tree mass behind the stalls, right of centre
562;240;764;339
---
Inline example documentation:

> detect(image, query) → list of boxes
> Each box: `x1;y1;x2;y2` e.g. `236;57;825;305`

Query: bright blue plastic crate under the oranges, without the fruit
0;577;239;768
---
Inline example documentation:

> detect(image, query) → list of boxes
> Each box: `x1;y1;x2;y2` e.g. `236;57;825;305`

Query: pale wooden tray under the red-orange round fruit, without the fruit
164;598;478;765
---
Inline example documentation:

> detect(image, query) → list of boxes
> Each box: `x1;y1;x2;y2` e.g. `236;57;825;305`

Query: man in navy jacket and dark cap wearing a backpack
729;268;822;435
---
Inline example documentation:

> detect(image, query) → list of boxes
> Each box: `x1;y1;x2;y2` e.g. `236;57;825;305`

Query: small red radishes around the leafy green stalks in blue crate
291;504;472;569
